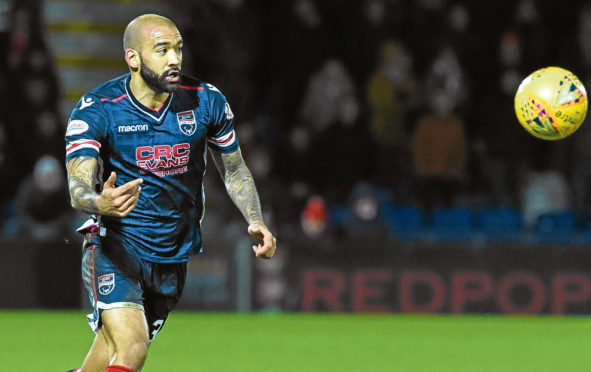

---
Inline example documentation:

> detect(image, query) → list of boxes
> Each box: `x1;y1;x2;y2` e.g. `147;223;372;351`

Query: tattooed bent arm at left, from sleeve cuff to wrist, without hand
66;156;98;213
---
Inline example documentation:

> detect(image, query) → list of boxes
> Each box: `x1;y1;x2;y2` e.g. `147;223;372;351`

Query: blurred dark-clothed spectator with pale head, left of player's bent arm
5;155;74;241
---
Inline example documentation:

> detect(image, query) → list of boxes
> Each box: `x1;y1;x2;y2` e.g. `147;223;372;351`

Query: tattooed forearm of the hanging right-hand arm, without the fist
221;150;263;224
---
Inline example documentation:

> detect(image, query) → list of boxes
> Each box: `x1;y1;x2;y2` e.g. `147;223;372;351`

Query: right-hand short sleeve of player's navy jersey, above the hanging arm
205;84;239;154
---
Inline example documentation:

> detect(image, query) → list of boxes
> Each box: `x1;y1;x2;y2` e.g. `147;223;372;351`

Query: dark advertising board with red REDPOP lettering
288;241;591;314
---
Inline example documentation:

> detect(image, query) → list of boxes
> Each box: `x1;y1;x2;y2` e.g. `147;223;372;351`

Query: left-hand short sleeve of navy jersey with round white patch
66;95;107;162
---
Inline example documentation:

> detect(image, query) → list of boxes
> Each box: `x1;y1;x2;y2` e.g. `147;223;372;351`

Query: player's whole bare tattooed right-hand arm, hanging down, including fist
212;148;277;258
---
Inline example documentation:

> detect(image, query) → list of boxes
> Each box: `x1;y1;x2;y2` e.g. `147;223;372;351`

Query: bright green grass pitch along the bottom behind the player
0;311;591;372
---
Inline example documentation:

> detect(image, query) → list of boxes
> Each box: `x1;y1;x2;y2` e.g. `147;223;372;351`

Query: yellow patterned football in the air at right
515;67;587;141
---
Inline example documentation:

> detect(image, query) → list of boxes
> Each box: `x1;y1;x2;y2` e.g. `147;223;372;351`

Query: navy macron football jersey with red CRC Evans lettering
66;74;238;263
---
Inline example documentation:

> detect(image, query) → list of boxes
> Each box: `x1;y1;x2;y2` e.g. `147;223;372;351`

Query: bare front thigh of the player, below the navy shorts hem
101;308;149;372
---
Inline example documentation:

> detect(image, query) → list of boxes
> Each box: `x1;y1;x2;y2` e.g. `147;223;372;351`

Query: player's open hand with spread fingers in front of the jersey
96;172;144;217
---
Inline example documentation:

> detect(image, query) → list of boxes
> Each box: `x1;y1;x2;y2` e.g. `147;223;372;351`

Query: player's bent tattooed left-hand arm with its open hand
66;156;143;217
